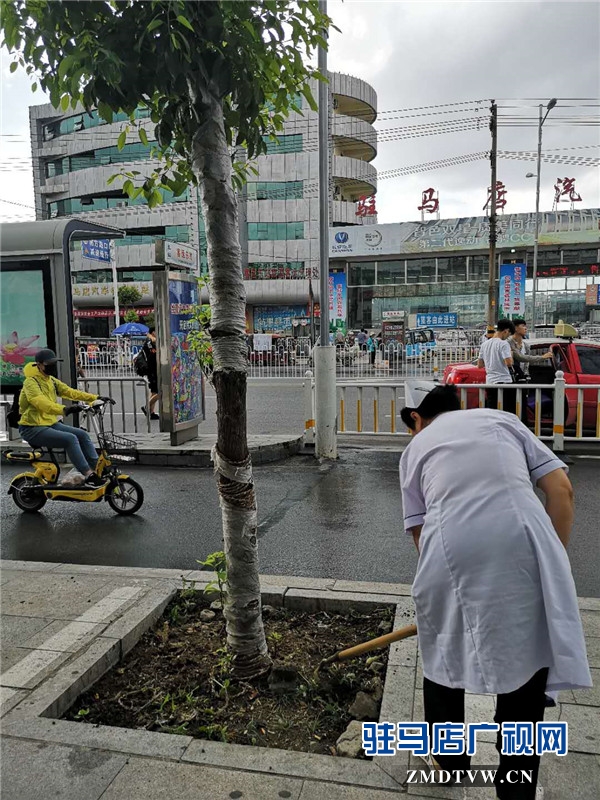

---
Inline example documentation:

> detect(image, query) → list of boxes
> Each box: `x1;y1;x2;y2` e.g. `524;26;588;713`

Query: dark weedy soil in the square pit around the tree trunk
64;589;404;755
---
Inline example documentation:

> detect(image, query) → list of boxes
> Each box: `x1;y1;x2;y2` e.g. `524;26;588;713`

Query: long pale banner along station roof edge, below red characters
329;208;600;258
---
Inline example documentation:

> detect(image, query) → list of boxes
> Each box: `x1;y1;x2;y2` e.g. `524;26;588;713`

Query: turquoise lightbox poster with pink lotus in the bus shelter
0;269;49;387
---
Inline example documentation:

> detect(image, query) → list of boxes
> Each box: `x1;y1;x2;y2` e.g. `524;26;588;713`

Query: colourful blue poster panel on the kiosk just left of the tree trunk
169;280;204;425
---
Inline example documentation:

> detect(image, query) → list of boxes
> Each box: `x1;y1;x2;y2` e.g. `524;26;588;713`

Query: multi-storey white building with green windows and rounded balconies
30;73;377;336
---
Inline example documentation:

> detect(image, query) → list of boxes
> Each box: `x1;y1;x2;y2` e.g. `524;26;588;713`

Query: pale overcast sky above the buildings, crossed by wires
0;0;600;222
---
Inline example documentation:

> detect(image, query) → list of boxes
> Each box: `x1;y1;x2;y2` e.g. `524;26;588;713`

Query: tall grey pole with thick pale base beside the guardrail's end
314;0;337;459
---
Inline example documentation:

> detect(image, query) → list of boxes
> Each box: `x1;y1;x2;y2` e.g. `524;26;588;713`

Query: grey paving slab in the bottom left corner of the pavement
1;738;127;800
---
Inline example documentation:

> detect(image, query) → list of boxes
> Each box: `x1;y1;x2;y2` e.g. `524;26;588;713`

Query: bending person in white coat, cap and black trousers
400;382;592;800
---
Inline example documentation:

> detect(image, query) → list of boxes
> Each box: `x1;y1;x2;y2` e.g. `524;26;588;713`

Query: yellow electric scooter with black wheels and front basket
6;400;144;515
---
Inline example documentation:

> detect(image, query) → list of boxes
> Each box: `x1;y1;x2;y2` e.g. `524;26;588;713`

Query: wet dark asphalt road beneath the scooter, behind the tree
0;448;600;597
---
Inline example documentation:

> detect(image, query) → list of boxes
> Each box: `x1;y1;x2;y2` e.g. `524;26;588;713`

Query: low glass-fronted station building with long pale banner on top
330;208;600;329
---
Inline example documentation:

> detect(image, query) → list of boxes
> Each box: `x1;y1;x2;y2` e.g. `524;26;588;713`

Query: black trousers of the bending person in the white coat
423;667;548;800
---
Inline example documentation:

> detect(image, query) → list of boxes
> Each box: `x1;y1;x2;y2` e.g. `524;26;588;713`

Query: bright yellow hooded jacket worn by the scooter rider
19;363;98;427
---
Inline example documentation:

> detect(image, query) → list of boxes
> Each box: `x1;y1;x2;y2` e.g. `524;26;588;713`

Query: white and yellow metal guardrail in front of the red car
304;371;600;452
